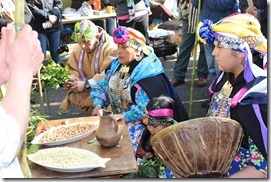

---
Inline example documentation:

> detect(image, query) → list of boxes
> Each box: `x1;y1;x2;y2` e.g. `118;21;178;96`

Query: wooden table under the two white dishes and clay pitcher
28;116;138;178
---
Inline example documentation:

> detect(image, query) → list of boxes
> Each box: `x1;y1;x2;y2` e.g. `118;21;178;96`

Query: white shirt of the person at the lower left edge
0;106;24;178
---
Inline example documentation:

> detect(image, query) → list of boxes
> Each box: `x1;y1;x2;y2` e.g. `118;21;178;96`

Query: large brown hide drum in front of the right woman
151;117;243;178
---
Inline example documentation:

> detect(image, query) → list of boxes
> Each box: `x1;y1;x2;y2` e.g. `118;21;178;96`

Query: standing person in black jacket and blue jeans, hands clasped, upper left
26;0;63;63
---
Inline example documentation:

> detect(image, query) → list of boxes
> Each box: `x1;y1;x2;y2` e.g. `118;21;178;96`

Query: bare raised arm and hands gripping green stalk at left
0;24;44;157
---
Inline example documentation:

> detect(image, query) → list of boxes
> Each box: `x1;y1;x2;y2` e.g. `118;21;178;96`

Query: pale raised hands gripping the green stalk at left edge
1;24;44;81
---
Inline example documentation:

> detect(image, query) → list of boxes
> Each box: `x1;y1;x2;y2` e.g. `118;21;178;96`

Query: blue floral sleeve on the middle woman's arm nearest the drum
123;84;150;123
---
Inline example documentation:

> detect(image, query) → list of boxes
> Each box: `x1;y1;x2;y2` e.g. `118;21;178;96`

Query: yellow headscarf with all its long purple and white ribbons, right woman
197;14;267;154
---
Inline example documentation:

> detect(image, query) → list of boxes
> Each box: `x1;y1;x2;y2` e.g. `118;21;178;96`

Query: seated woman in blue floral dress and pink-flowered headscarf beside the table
90;27;188;152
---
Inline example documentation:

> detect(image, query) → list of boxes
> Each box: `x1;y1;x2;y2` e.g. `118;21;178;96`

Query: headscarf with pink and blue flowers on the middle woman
113;26;146;49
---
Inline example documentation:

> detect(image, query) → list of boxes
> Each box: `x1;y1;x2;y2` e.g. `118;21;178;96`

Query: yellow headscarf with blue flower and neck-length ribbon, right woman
197;14;267;83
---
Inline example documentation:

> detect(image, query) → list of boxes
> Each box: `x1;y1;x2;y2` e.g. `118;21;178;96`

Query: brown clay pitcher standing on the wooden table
96;109;121;147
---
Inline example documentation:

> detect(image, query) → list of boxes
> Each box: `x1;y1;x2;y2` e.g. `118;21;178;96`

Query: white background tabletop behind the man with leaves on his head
62;13;116;24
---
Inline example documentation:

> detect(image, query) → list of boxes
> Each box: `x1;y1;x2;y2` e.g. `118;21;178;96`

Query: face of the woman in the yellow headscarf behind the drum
212;45;242;73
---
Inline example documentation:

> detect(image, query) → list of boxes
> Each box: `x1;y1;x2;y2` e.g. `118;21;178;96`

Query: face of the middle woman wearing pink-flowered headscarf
117;42;137;65
